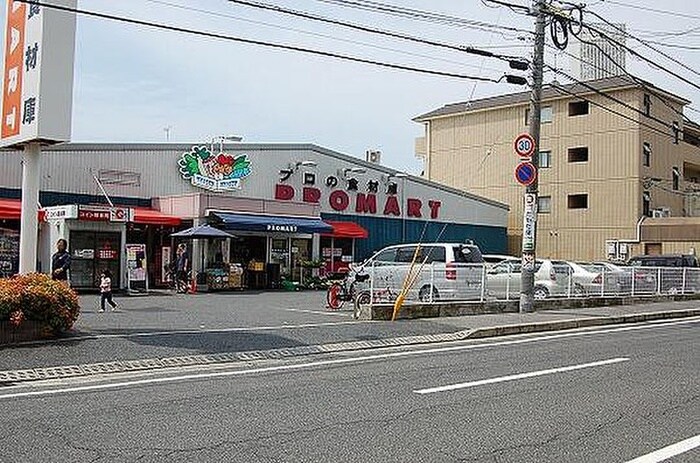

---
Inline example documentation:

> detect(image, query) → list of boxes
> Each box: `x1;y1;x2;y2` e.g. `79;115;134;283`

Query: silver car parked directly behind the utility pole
486;258;565;299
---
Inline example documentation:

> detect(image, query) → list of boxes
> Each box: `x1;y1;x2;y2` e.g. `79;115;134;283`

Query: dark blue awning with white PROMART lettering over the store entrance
212;212;333;233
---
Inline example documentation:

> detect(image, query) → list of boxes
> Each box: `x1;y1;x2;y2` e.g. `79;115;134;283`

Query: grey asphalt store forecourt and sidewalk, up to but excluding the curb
0;291;698;370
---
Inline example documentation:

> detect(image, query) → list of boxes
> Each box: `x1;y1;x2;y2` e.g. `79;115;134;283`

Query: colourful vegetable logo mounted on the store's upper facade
178;146;252;192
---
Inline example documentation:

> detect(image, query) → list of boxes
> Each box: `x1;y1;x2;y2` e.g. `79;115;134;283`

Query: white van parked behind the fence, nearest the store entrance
354;243;484;301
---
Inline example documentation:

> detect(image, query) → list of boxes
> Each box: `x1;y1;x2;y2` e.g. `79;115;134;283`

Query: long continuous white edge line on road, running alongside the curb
0;318;700;400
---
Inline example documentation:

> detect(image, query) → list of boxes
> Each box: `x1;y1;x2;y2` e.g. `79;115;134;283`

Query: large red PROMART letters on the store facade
275;183;442;219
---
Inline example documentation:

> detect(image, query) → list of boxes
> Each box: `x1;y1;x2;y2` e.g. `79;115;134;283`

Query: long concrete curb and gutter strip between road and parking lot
0;308;700;385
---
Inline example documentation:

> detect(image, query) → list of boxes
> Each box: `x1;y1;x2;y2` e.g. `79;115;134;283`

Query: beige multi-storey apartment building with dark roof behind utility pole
414;76;700;260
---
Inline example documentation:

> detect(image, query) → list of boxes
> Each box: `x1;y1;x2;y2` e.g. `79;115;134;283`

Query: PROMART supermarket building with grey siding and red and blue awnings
0;143;508;289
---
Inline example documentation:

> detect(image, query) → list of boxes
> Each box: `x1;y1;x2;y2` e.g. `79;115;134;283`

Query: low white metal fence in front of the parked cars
355;263;700;303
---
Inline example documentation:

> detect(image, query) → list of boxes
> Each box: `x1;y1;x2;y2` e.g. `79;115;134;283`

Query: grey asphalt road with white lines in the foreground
0;319;700;463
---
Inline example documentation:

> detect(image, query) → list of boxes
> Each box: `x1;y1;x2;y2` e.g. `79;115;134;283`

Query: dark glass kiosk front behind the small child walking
69;231;121;289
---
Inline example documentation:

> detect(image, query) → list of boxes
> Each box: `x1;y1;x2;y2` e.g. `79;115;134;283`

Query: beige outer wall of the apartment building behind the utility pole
426;88;700;260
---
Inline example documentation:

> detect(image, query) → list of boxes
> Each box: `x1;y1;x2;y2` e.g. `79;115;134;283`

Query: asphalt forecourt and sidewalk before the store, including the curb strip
0;292;700;382
